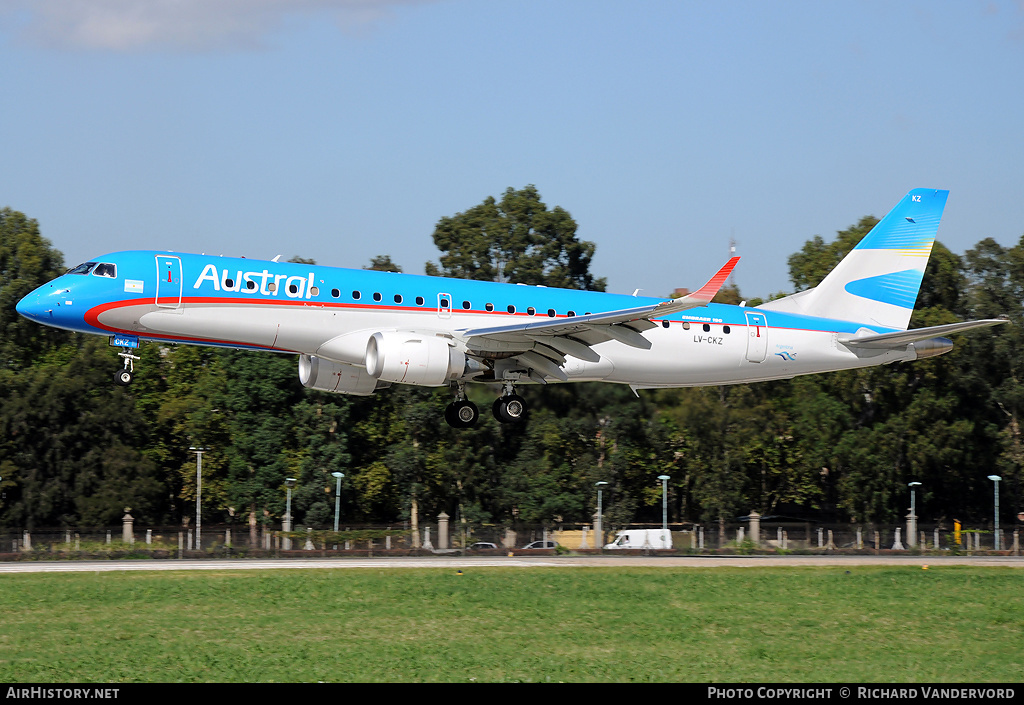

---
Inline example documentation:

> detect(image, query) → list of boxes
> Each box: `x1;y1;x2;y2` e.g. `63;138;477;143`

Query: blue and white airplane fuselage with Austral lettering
18;251;919;388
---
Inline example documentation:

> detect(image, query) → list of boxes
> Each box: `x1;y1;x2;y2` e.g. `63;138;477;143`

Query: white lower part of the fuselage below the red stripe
97;300;916;388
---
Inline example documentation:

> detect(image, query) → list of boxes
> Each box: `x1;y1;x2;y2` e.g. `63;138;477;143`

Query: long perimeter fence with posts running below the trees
0;516;1021;561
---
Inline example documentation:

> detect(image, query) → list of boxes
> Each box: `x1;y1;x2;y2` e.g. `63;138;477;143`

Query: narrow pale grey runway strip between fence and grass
0;555;1024;574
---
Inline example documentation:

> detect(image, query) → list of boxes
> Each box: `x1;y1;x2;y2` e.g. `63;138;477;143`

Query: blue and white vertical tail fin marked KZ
760;189;949;330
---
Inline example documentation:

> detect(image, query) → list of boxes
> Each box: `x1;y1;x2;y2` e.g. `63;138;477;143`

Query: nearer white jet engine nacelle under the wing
366;331;466;386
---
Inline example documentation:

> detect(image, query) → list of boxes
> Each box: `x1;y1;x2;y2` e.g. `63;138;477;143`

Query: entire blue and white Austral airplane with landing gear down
16;189;1007;428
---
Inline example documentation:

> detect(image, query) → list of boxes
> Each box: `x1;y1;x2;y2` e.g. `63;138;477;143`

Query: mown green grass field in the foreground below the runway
0;566;1024;682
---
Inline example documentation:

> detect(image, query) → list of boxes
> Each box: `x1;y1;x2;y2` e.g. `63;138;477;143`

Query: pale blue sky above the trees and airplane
0;0;1024;297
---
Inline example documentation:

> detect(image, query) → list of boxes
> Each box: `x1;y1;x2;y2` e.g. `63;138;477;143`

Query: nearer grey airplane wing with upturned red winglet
456;257;739;382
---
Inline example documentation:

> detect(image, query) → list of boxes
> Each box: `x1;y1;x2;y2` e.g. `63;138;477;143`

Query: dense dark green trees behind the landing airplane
0;186;1024;533
